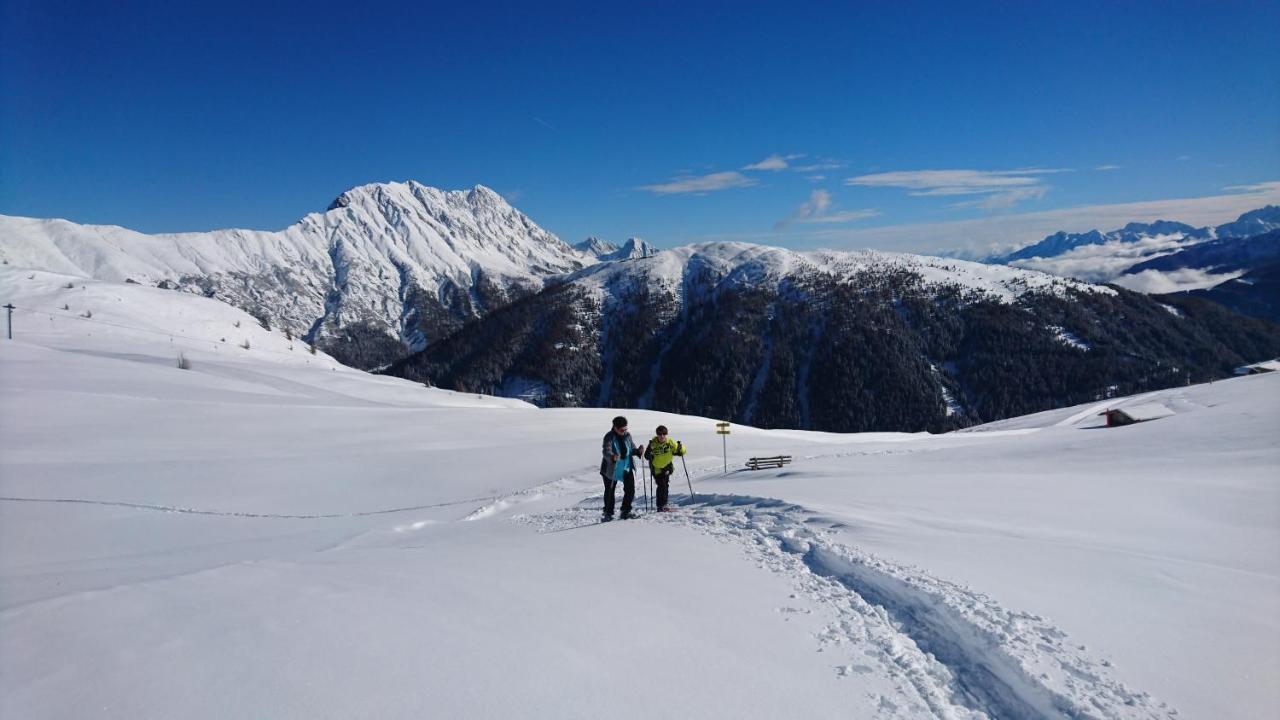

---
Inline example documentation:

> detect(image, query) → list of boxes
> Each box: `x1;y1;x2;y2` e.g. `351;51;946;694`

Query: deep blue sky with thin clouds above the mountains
0;0;1280;252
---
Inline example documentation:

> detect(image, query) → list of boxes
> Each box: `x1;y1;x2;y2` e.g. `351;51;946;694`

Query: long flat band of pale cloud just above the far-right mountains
792;181;1280;258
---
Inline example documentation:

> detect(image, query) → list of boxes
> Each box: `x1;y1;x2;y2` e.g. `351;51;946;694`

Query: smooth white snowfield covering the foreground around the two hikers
0;266;1280;719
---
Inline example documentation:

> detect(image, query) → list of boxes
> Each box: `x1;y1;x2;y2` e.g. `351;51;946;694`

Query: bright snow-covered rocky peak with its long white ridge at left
0;182;595;364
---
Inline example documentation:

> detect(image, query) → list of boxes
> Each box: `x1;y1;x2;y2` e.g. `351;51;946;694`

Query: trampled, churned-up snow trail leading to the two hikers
496;461;1178;720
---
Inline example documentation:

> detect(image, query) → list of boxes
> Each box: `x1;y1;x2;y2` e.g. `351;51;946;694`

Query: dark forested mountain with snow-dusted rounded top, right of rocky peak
387;243;1280;432
